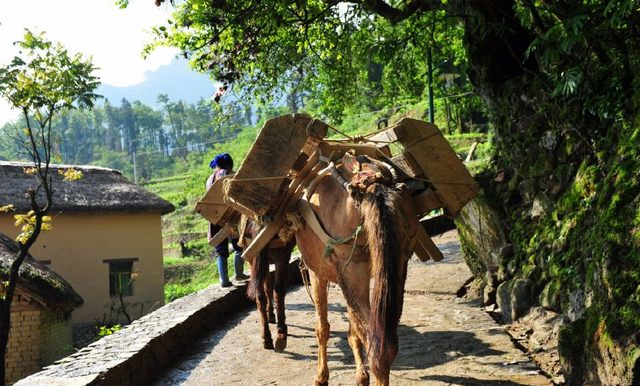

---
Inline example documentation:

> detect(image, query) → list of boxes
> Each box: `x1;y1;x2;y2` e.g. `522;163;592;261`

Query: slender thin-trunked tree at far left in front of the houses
0;30;98;386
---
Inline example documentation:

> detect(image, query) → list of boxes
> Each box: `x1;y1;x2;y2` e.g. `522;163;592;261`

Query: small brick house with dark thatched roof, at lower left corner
0;234;82;383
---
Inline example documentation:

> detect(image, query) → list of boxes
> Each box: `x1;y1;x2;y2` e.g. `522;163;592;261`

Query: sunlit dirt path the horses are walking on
149;232;552;386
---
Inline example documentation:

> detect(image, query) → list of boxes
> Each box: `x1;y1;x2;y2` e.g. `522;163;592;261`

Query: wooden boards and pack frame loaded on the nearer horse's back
196;114;478;261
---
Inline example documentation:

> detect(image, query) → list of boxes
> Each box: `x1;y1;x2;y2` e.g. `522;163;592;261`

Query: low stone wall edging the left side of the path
15;260;302;386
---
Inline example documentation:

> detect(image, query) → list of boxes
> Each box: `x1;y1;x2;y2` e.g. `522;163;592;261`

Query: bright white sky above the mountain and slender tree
0;0;177;126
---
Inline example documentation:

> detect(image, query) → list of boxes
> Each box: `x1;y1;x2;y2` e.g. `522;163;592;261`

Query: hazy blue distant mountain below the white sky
96;59;216;106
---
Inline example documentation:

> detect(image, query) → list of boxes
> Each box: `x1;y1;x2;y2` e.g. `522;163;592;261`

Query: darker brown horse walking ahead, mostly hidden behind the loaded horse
244;220;295;351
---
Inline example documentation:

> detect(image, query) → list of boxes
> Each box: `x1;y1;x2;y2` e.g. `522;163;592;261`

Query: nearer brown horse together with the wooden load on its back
196;115;477;385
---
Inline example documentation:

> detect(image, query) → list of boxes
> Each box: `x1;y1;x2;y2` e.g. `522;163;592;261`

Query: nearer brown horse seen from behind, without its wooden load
296;156;417;386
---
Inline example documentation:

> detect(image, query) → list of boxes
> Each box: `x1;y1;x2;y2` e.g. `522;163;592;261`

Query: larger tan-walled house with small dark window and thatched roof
0;161;175;324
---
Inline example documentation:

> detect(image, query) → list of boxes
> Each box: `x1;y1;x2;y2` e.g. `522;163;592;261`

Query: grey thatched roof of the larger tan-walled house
0;161;175;214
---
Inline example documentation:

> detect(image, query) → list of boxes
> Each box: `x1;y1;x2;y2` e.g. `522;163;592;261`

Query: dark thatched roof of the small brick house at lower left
0;233;83;310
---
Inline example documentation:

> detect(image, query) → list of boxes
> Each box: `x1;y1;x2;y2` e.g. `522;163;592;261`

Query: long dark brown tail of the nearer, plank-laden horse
361;184;407;374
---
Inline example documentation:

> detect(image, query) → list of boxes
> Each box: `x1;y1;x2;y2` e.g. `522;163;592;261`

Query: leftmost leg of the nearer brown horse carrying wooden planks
309;271;330;386
